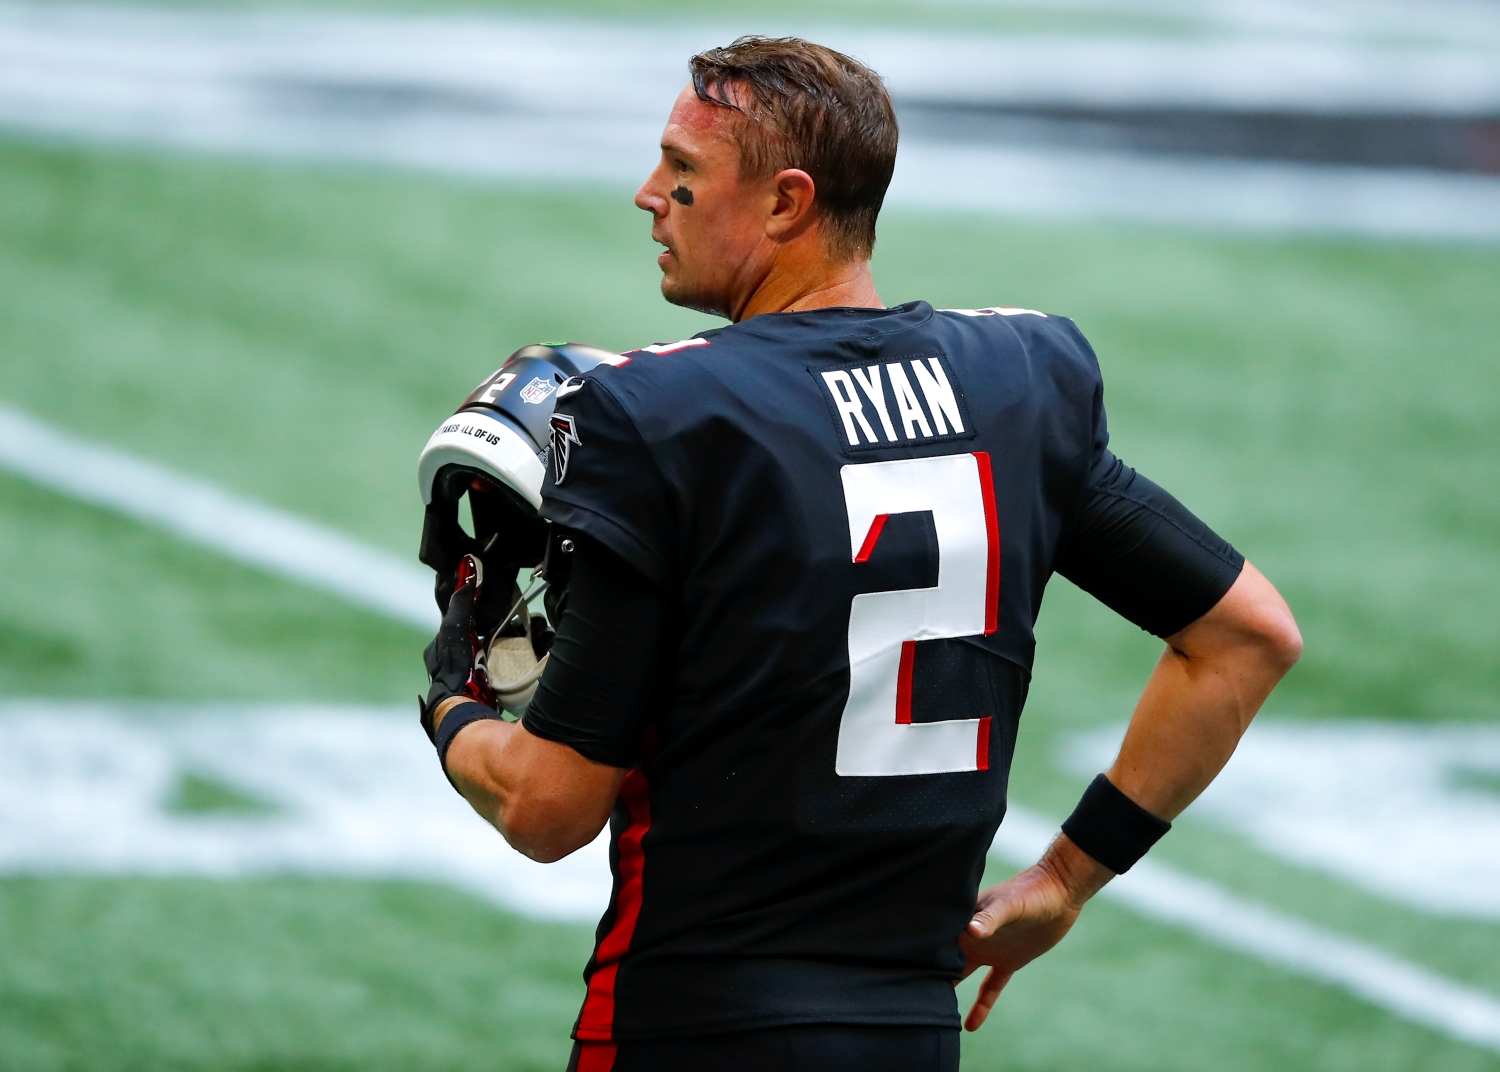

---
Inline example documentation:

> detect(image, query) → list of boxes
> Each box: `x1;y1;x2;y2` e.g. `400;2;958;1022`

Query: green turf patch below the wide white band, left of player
0;879;591;1072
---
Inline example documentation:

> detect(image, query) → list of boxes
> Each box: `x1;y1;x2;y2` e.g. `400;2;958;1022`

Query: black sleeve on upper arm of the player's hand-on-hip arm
1056;450;1245;637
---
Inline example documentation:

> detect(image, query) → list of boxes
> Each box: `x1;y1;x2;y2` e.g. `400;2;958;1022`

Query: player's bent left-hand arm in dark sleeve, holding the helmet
429;370;675;862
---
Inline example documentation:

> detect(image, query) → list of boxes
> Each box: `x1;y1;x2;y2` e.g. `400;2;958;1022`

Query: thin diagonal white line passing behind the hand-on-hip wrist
993;805;1500;1053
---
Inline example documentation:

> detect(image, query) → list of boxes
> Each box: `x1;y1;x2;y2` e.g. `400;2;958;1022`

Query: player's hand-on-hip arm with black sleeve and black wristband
960;454;1302;1030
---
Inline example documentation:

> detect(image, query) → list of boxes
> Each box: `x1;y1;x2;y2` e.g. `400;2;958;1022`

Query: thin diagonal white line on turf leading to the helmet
0;403;438;630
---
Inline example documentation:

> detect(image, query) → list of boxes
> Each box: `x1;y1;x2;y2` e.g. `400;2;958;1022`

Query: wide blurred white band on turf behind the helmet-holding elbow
0;700;611;921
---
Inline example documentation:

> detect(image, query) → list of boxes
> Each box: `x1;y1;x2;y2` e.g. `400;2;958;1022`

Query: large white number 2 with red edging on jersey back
836;453;1001;777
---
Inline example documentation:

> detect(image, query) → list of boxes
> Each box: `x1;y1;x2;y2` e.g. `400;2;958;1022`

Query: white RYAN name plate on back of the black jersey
809;354;974;450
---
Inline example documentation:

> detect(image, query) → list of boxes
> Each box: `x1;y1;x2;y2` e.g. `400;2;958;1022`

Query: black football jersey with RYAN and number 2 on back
528;303;1242;1041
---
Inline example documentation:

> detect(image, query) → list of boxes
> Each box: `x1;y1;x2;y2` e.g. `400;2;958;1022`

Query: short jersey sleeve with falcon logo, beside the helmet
540;378;677;585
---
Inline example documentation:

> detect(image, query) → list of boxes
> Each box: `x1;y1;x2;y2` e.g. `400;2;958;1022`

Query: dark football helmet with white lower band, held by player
417;342;621;714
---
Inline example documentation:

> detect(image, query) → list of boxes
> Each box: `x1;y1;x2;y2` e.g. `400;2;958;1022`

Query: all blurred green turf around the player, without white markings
0;0;1500;1072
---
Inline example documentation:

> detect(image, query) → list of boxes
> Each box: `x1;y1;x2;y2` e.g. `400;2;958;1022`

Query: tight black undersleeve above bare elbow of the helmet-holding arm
521;534;669;768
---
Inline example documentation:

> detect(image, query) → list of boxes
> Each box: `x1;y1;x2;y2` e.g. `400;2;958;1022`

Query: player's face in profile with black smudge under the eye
636;85;770;316
